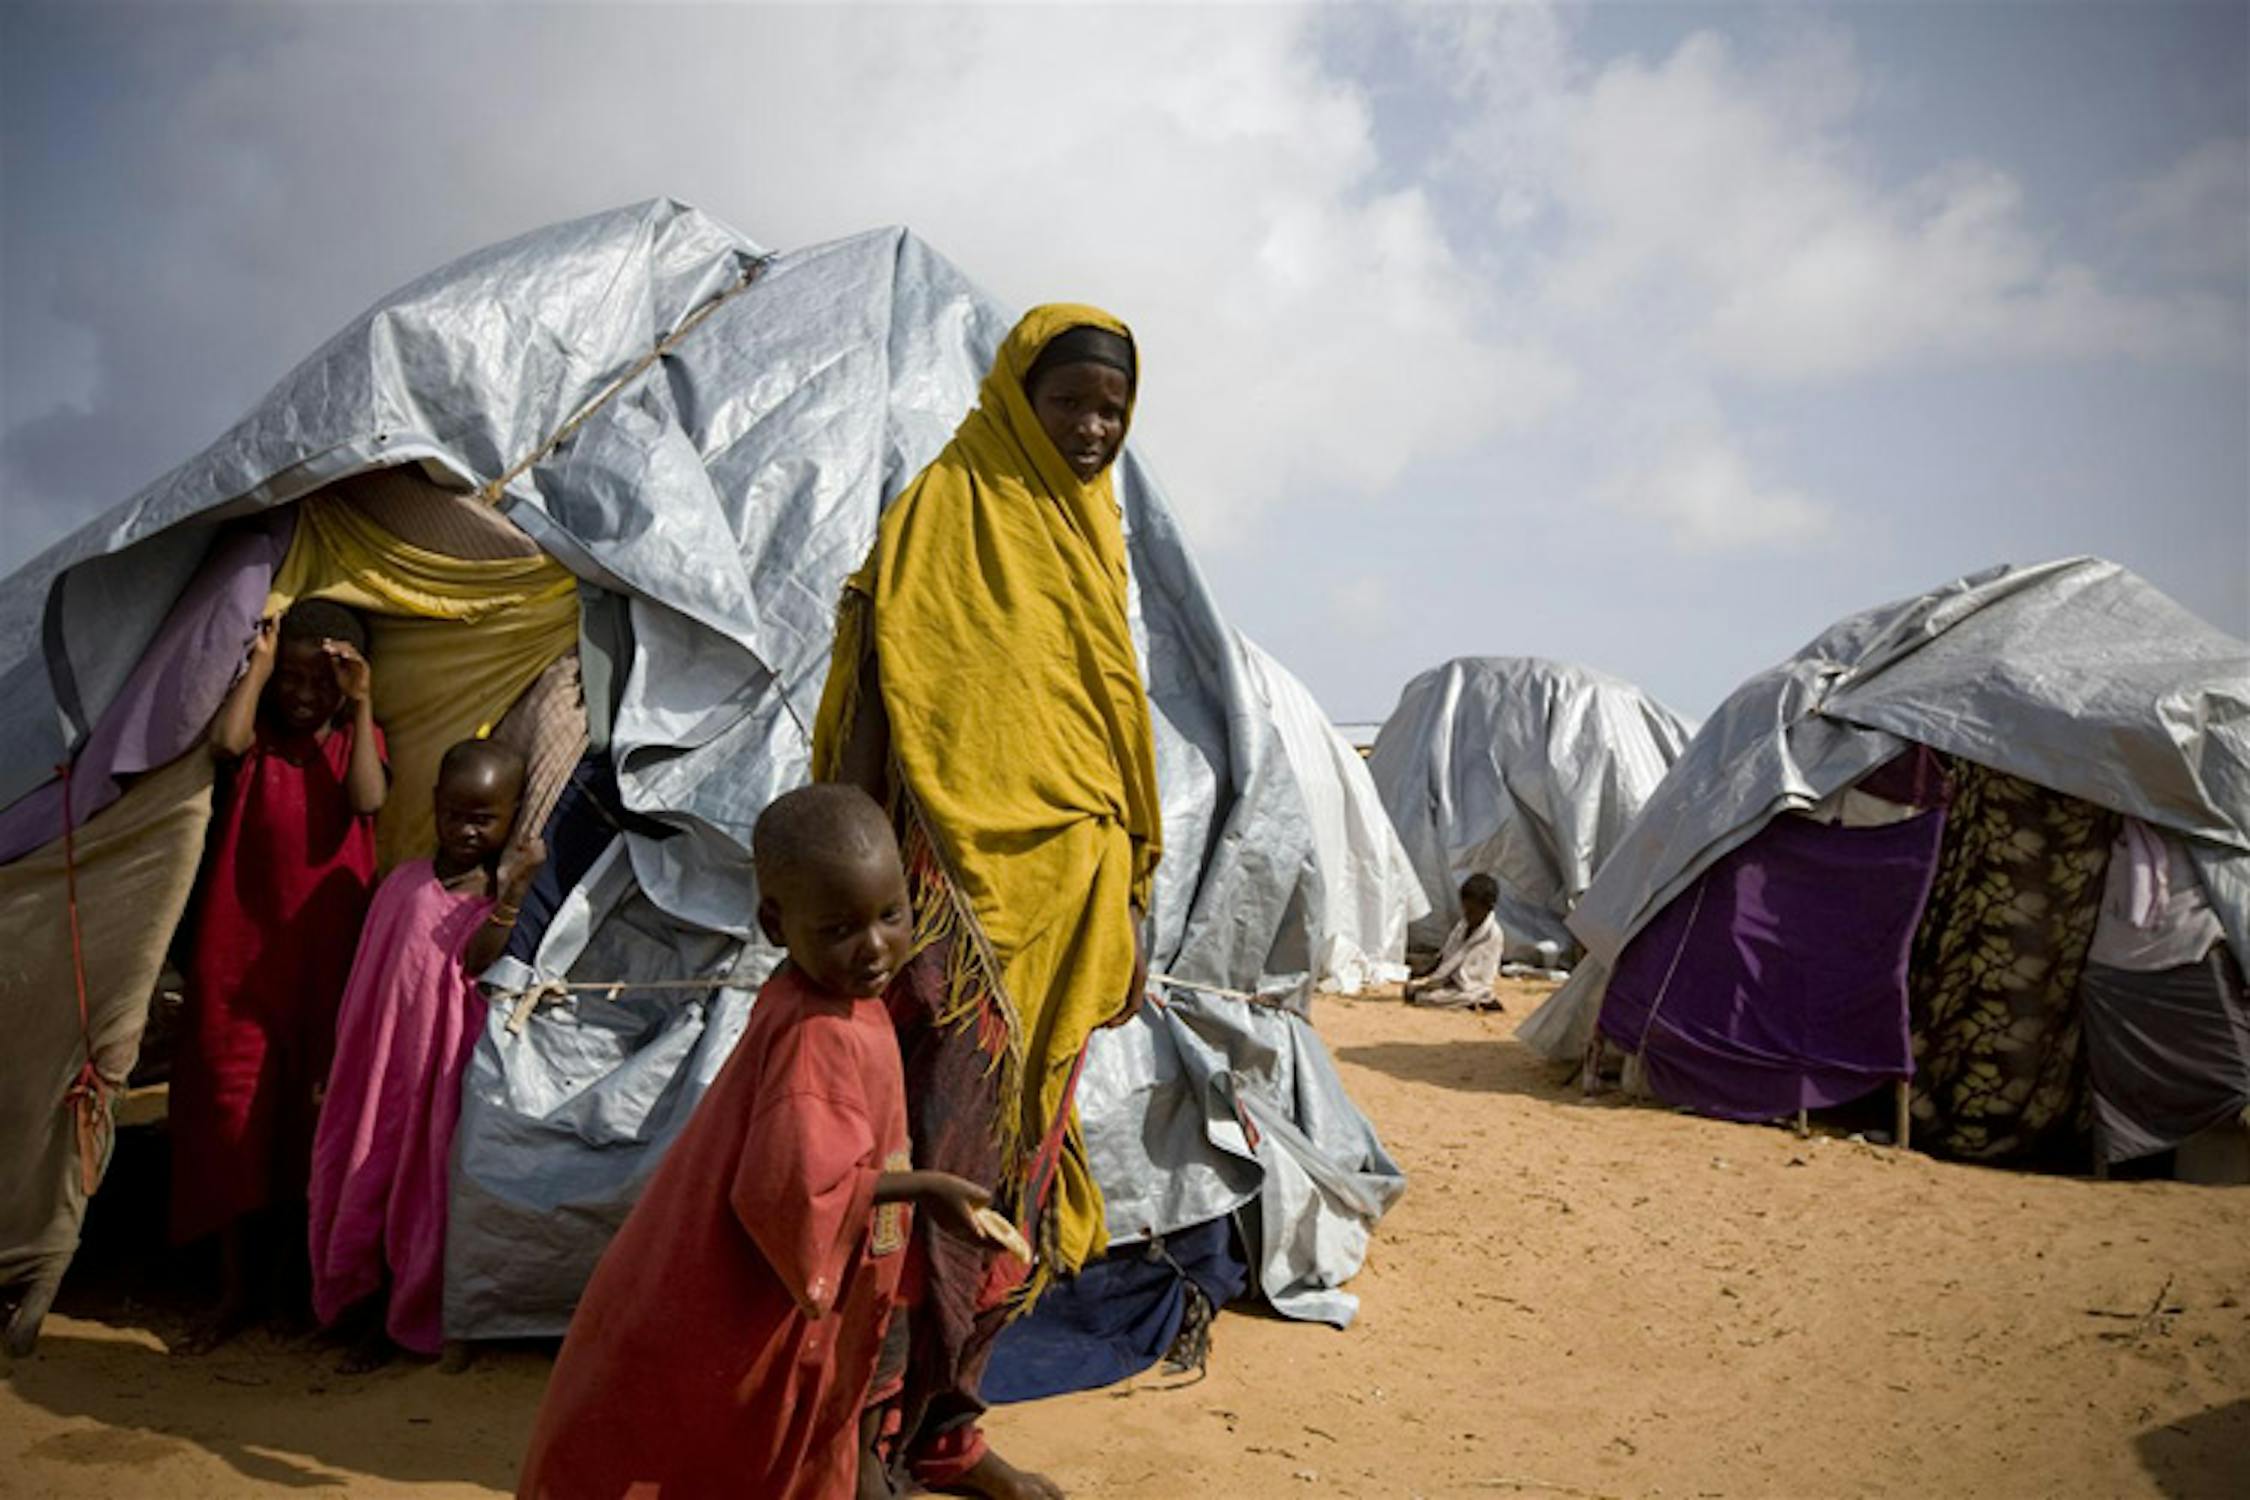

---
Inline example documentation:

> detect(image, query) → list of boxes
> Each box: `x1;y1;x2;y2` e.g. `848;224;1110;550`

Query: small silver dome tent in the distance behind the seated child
1368;657;1692;954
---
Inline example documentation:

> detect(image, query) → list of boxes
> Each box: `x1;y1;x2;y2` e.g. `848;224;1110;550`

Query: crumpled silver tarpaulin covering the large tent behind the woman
0;200;1397;1336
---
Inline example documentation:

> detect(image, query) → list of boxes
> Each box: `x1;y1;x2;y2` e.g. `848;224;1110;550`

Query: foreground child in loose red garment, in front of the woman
518;783;1012;1500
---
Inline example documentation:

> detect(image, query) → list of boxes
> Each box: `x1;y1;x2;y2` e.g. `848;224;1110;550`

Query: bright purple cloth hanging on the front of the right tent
1602;810;1946;1120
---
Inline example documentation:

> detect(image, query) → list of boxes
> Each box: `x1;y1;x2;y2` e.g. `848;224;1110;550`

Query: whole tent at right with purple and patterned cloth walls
1523;558;2250;1160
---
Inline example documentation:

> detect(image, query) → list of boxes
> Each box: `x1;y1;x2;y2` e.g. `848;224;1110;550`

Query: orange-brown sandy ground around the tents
0;994;2250;1500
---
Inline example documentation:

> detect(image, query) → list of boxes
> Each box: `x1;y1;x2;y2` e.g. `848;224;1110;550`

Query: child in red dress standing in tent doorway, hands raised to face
171;600;389;1354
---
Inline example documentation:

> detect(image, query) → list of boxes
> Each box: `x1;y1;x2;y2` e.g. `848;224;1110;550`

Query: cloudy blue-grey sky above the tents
0;0;2250;720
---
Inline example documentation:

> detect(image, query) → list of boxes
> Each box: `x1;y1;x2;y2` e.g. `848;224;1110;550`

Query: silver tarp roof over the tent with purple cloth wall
1519;558;2250;1059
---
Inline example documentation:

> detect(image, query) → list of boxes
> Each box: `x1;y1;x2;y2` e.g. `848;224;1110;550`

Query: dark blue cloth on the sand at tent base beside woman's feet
981;1219;1251;1406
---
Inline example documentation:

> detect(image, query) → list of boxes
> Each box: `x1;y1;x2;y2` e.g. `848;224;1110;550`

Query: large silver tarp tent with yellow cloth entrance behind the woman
0;200;1404;1343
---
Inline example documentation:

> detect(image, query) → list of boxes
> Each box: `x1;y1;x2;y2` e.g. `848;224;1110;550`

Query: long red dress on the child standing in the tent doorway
169;722;383;1244
